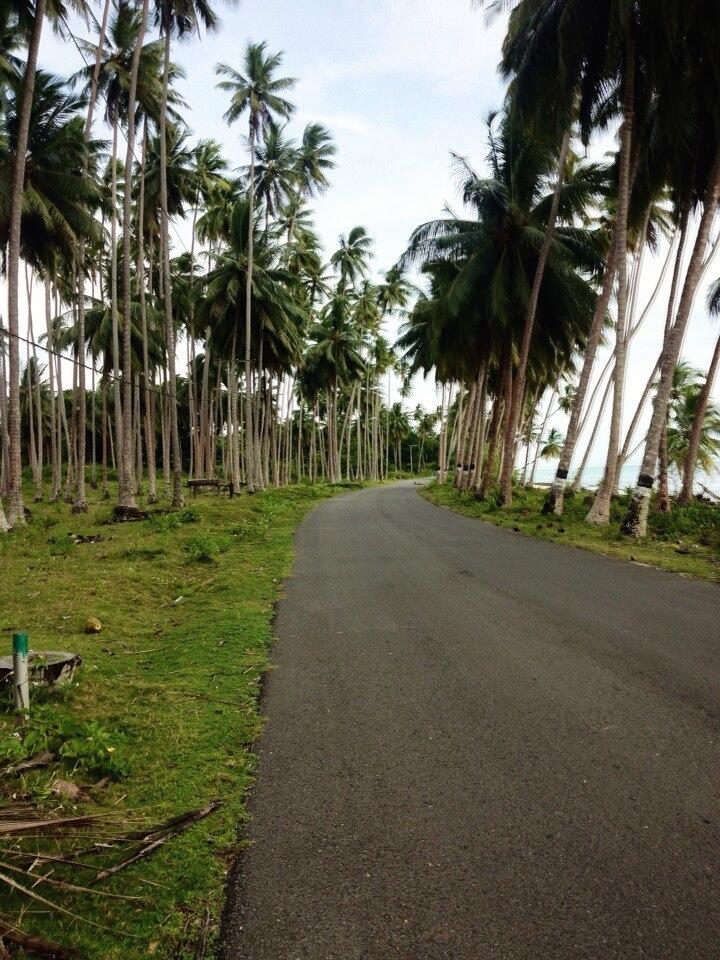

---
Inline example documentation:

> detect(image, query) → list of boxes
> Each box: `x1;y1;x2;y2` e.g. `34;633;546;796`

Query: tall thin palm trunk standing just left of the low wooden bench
159;23;183;508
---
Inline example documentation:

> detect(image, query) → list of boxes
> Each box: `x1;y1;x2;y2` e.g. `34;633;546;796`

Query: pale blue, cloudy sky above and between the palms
31;0;720;480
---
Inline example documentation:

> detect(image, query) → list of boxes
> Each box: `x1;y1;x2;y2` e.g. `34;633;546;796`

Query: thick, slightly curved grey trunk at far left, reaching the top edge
7;0;46;527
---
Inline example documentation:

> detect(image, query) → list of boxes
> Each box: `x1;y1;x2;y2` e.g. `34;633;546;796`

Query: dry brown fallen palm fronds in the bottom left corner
0;803;220;960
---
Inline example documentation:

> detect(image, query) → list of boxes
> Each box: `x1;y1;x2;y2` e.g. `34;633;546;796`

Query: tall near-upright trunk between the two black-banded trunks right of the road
587;31;644;524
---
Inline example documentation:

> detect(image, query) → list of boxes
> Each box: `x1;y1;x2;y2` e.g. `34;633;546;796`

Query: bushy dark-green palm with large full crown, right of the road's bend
401;117;603;502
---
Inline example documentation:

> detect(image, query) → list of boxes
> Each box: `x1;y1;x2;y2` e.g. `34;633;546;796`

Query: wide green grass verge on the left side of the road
0;486;354;960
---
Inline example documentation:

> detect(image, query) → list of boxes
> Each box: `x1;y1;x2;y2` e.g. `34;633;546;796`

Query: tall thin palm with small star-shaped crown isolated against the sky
217;42;295;491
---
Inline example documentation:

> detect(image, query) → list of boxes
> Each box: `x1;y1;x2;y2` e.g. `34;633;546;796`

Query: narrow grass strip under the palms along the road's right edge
422;483;720;583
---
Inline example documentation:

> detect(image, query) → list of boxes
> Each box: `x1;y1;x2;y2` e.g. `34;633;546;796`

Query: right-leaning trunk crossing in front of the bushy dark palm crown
500;129;570;506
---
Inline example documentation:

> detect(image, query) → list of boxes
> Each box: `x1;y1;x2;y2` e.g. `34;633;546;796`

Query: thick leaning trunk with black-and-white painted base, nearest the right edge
623;153;720;537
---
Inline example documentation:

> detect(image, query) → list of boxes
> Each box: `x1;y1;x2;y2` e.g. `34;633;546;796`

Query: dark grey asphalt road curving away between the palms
224;484;720;960
